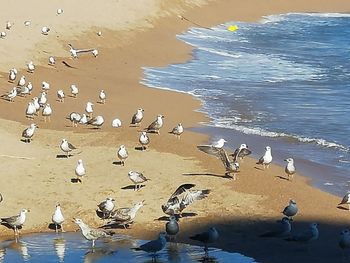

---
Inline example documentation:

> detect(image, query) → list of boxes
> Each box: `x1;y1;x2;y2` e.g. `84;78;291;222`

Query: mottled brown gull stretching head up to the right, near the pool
107;200;145;229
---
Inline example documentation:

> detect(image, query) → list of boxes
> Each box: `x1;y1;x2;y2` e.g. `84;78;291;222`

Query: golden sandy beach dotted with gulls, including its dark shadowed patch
0;0;350;262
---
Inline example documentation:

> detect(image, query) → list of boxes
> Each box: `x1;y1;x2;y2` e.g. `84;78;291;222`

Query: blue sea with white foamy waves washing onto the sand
142;13;350;195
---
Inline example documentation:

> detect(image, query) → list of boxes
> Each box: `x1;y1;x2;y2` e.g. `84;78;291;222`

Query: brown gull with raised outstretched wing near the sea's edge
197;145;239;180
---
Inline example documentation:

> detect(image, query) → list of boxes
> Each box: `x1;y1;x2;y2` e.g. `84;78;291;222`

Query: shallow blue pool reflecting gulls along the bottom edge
0;233;255;263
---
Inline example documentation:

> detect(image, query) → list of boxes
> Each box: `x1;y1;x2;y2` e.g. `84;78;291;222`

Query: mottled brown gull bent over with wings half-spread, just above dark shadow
162;184;210;217
